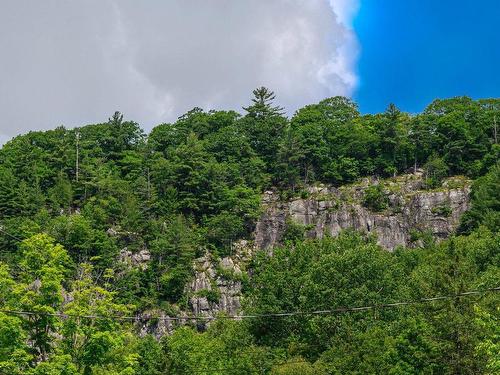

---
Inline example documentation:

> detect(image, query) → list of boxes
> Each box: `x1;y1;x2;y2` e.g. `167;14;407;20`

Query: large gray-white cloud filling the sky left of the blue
0;0;358;144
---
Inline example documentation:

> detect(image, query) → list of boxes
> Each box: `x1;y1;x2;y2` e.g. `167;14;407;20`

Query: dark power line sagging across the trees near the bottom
0;286;500;322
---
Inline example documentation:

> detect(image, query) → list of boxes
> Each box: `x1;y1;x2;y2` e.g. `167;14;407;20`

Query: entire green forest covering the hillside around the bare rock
0;87;500;375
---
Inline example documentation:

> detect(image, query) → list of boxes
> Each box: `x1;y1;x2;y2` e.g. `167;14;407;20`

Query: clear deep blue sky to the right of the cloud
353;0;500;113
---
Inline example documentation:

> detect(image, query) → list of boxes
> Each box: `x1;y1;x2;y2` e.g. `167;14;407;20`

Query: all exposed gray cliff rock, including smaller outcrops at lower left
130;173;470;337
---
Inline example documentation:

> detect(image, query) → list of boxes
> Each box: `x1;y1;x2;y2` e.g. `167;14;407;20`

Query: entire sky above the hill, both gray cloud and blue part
0;0;500;144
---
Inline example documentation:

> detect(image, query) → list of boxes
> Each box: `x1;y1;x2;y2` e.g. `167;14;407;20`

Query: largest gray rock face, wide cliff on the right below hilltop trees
255;175;470;250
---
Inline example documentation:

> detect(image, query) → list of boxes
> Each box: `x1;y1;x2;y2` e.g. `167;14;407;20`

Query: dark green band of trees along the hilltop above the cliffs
0;92;500;239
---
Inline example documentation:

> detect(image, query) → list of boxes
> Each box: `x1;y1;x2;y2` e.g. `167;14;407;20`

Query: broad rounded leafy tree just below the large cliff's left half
247;233;401;356
